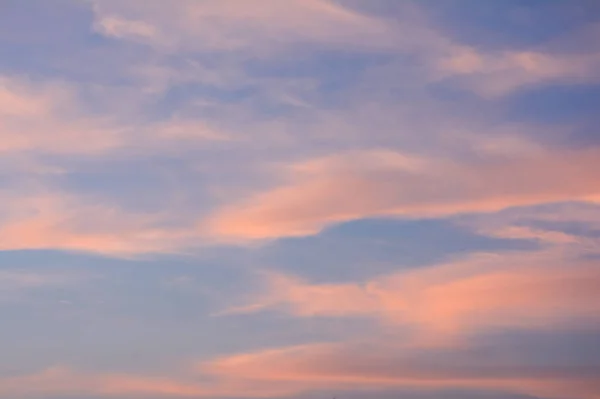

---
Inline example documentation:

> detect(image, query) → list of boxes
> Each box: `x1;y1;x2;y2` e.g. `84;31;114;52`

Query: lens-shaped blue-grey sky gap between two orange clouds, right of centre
255;219;535;282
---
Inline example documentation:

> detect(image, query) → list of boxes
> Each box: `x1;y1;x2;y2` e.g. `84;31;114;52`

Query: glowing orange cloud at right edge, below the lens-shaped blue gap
380;256;600;334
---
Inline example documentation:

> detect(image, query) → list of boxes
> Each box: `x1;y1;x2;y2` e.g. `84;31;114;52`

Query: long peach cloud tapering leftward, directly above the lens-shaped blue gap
204;149;600;240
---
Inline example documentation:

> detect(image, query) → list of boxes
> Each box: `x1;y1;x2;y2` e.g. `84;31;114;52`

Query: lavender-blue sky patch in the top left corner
0;0;129;81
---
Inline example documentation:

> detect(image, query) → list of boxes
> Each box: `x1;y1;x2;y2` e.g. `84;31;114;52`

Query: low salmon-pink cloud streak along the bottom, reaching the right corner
199;344;600;399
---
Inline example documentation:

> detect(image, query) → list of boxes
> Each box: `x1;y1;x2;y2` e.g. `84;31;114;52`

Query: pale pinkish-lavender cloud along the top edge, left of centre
94;0;391;51
